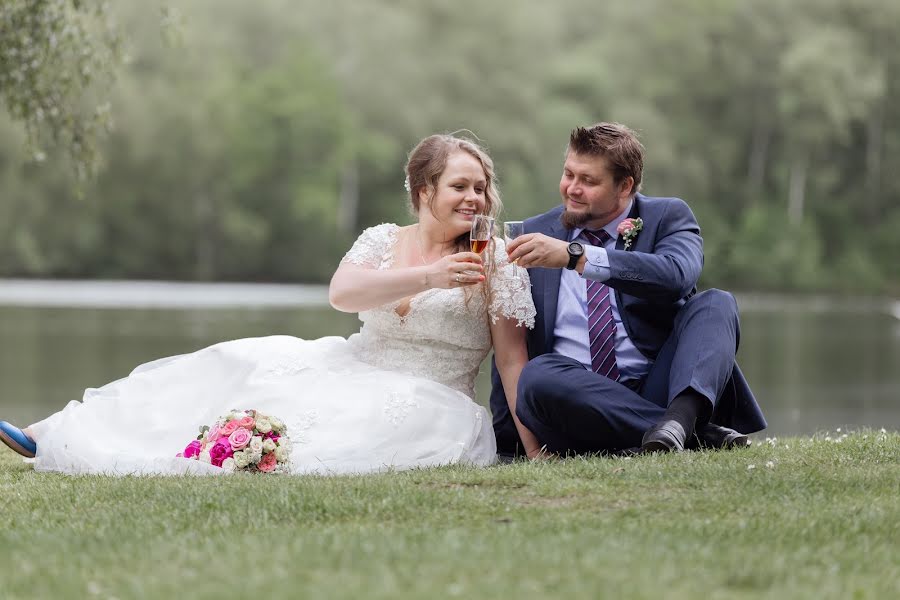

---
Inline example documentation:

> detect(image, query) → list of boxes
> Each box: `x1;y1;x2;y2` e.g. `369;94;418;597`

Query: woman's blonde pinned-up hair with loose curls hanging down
406;132;503;299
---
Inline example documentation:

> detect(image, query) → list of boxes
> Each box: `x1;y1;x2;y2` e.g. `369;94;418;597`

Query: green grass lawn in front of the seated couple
0;431;900;600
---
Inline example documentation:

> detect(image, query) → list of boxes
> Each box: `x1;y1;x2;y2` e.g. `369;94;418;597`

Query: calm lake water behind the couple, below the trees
0;282;900;436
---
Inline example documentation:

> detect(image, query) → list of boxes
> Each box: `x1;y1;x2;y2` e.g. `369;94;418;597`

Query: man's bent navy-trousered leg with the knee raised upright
641;290;740;424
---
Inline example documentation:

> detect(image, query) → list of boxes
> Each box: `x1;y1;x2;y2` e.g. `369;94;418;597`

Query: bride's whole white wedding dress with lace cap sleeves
32;224;535;475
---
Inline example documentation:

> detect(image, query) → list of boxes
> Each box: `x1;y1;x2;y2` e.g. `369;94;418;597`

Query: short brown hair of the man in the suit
566;123;644;193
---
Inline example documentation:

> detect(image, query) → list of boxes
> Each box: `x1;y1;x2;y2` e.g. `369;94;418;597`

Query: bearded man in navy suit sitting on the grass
491;123;766;455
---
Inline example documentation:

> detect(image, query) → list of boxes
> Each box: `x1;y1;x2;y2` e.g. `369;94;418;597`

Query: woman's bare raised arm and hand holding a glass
328;252;484;312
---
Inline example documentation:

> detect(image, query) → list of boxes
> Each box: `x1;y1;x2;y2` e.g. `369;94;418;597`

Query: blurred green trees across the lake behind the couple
0;0;900;293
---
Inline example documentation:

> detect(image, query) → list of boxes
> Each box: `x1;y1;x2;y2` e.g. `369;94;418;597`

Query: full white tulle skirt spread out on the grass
32;336;496;475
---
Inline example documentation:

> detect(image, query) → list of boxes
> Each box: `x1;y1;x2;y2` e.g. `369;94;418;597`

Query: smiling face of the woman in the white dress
419;152;487;237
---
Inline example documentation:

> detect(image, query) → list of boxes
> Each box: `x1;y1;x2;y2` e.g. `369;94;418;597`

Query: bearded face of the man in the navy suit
559;152;633;229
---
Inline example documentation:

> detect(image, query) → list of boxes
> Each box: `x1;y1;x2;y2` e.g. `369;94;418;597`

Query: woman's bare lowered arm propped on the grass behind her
491;318;541;458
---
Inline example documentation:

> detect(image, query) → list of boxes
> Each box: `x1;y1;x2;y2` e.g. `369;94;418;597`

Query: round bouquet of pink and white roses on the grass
177;410;291;473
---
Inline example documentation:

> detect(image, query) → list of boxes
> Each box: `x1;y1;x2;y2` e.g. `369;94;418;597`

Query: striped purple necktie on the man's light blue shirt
583;229;619;381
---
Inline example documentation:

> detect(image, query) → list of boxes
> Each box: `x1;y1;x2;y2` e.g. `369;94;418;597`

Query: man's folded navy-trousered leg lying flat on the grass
516;354;665;454
